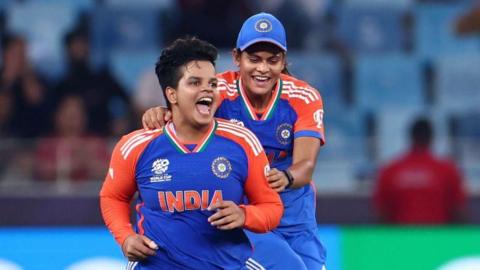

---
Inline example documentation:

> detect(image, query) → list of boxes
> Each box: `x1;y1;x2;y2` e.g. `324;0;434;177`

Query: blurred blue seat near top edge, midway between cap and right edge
335;5;406;53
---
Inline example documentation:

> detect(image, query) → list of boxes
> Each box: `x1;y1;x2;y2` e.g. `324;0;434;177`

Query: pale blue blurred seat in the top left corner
6;2;78;77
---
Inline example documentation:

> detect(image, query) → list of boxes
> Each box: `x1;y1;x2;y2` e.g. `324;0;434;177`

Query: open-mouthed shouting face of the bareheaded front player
165;61;217;128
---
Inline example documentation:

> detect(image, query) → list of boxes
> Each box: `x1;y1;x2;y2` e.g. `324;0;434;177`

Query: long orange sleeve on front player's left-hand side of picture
100;130;161;246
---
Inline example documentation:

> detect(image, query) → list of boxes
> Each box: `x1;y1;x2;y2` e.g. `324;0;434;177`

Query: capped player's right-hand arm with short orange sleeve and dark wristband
268;89;325;192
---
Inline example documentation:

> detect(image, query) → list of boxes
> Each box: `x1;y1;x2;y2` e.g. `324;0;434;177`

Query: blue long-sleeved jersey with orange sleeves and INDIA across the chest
100;119;283;269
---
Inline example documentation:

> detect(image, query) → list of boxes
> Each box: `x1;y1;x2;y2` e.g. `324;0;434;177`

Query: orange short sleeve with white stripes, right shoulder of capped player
281;74;325;145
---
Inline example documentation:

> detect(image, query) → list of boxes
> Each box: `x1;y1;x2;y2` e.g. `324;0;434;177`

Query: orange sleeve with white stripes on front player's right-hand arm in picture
218;120;283;232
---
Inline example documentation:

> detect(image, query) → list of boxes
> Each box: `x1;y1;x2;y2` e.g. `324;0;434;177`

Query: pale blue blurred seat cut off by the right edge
434;52;480;112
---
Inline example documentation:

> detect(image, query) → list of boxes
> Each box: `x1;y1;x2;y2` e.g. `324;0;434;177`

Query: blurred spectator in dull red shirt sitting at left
34;95;108;182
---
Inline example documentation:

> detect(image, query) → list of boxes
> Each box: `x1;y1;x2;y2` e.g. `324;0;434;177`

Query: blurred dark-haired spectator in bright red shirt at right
374;119;465;224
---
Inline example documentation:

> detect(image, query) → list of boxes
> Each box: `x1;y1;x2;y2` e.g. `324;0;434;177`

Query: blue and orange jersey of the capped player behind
215;71;325;230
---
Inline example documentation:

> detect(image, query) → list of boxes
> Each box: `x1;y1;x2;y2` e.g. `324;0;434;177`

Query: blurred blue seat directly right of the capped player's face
287;52;346;110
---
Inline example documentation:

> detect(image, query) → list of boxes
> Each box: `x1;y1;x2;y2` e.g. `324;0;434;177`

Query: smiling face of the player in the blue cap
234;42;285;96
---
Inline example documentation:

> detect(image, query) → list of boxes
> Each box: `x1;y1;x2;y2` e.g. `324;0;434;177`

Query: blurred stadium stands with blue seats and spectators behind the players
0;0;480;200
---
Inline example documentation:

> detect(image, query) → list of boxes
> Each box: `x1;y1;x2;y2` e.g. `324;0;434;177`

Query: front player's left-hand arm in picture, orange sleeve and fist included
100;137;158;261
